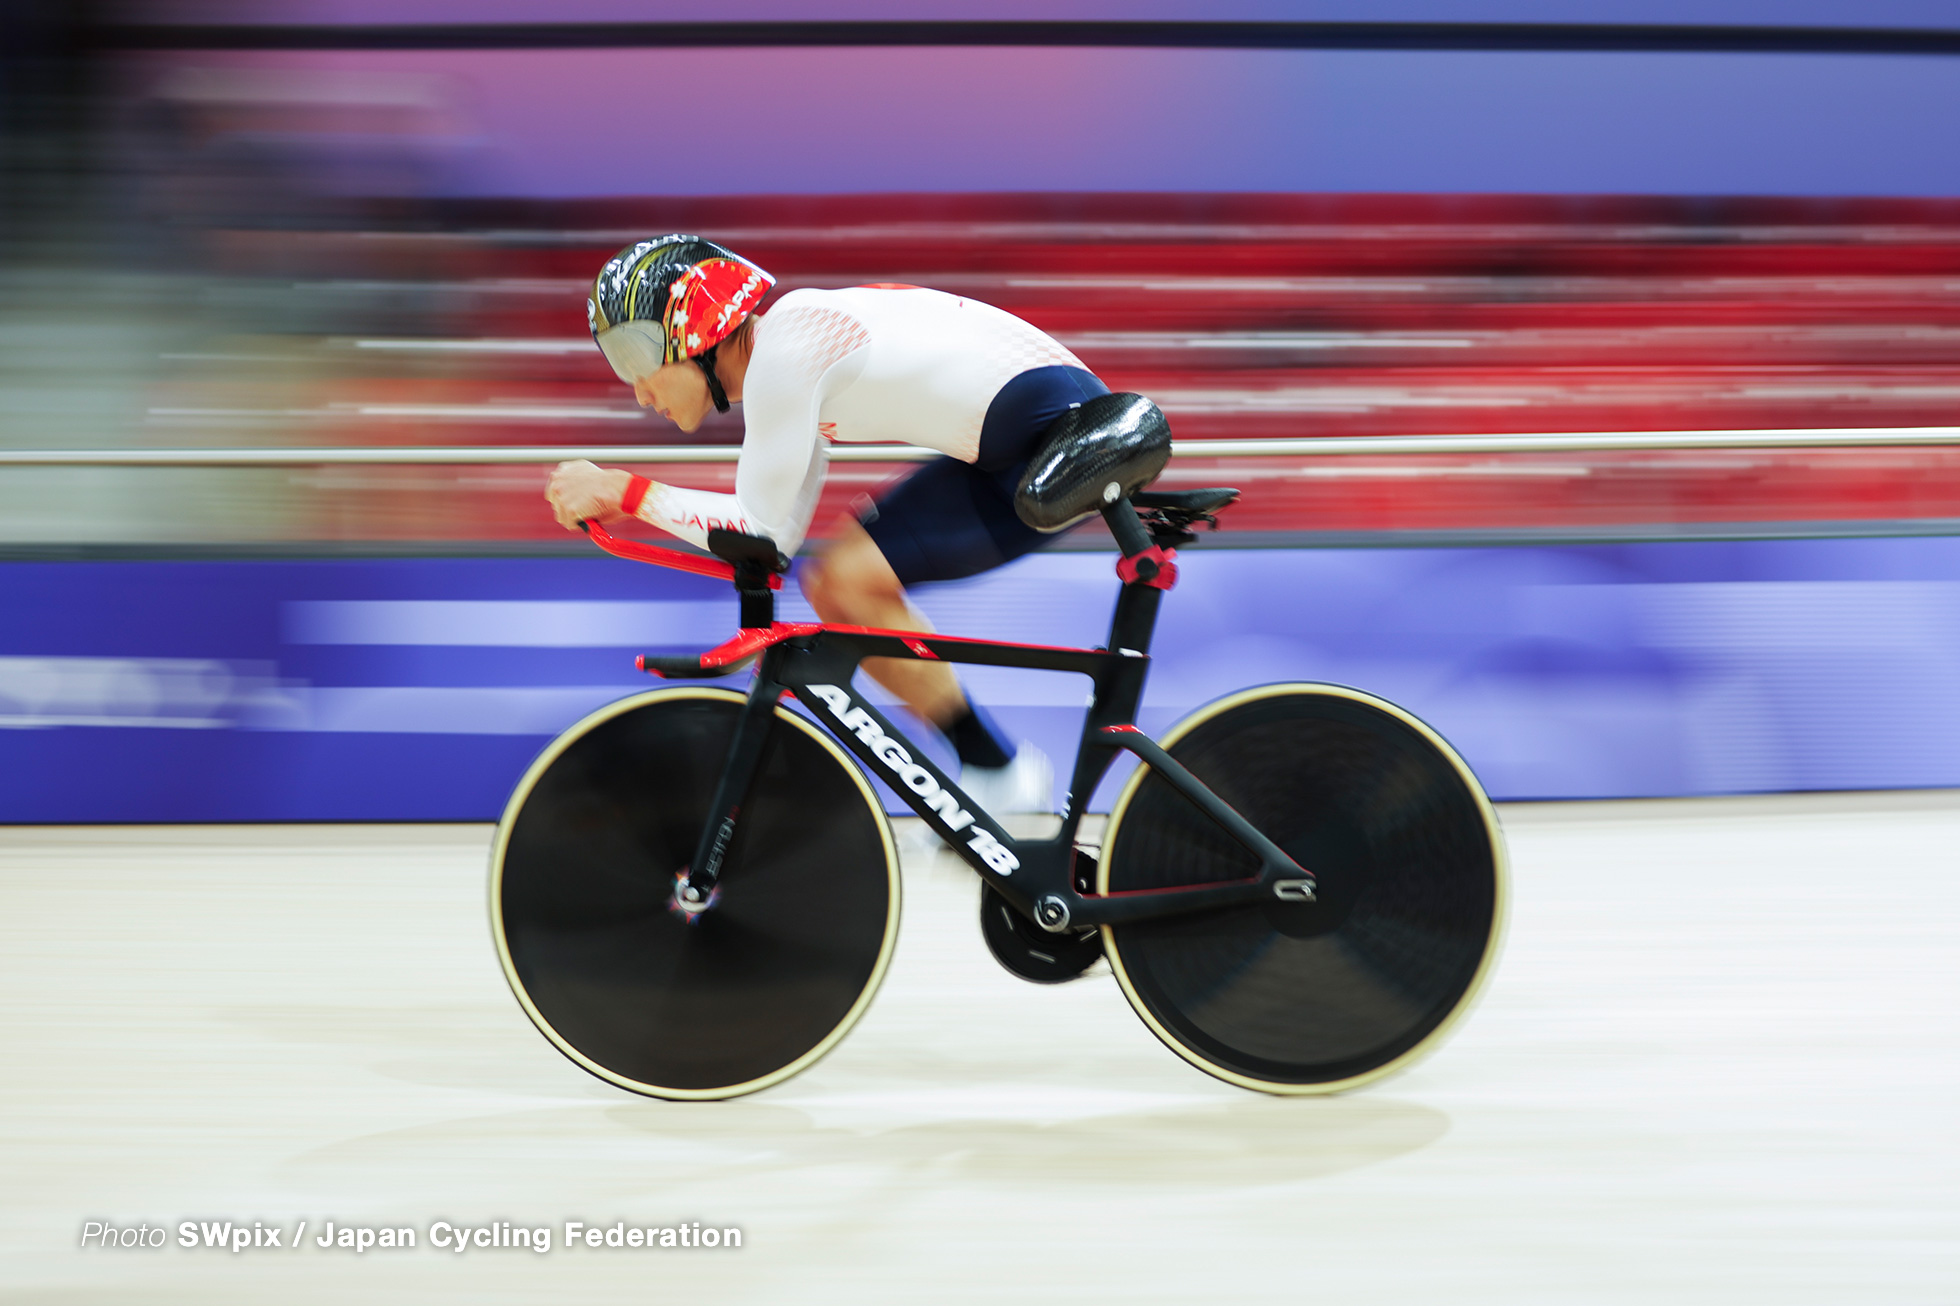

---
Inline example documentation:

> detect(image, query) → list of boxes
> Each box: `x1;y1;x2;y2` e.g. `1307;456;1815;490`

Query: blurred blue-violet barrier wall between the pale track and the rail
0;539;1960;822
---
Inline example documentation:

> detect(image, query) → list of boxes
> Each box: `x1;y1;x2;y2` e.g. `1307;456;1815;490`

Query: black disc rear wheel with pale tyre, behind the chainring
1098;684;1505;1092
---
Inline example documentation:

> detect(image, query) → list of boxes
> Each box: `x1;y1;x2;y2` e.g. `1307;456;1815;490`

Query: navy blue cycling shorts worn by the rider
858;367;1109;584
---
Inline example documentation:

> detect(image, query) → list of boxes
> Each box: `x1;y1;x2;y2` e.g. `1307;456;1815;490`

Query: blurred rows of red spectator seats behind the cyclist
191;196;1960;539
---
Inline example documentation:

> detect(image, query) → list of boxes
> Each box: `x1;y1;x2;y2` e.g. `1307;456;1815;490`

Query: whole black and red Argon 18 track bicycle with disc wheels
490;401;1505;1100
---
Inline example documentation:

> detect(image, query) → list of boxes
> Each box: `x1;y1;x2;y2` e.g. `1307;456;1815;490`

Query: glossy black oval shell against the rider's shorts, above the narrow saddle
1013;394;1170;531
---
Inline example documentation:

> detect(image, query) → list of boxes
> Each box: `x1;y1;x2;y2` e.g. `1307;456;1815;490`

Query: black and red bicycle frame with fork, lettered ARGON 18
666;500;1313;933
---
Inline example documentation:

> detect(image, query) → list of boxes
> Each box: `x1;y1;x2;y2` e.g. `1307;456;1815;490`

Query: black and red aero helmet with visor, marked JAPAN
586;235;776;412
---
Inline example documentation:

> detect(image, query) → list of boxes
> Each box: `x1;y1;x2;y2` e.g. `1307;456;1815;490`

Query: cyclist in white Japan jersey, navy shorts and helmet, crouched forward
545;235;1109;812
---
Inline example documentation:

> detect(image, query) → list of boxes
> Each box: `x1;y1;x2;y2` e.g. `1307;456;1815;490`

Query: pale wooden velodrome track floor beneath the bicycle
0;794;1960;1306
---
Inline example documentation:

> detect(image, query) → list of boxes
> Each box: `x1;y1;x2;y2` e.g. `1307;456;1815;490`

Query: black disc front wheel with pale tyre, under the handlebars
490;686;900;1098
